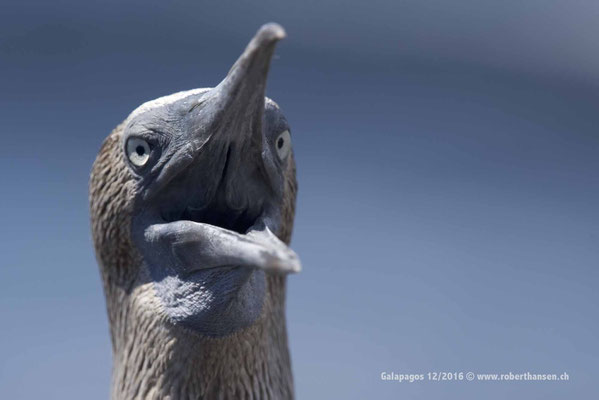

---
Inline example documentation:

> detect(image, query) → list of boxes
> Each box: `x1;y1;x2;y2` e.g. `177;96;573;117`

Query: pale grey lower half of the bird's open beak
145;221;301;274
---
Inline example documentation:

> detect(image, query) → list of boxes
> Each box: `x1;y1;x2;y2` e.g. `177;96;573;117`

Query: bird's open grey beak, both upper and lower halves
145;24;301;274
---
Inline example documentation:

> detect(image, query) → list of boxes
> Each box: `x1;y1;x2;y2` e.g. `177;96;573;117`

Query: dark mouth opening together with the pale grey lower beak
144;180;301;274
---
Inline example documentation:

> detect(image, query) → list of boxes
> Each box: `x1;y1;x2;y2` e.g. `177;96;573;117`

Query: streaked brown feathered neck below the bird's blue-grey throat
107;277;293;399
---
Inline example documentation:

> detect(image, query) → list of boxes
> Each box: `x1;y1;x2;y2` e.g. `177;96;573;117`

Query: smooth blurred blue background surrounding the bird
0;0;599;399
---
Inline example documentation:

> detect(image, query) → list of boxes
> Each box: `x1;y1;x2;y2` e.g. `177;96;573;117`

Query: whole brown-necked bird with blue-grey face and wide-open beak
89;23;301;399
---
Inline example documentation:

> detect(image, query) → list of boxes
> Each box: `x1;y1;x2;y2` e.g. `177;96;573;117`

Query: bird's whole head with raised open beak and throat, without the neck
90;24;300;336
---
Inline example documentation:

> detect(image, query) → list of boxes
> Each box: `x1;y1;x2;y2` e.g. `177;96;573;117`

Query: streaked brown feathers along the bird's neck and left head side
90;127;293;399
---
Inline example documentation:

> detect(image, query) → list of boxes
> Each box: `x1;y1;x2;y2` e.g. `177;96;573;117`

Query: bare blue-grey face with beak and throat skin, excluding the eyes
123;26;299;336
